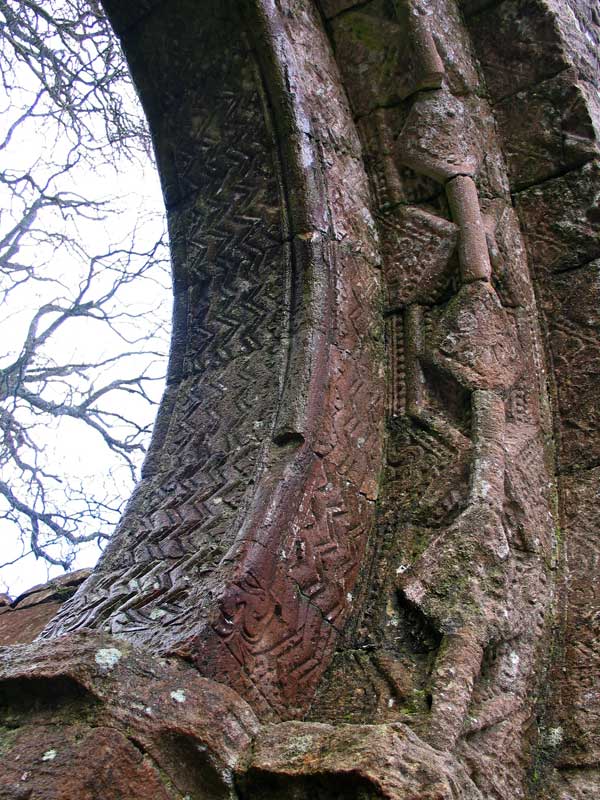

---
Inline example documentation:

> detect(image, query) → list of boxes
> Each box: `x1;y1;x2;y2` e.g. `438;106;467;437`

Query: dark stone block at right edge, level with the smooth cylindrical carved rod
515;161;600;277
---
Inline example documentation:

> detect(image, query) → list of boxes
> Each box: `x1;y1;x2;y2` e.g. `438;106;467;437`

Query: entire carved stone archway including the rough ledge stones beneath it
0;0;600;800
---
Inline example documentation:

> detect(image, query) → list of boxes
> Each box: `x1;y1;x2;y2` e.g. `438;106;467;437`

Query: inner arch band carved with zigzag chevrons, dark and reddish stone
46;0;384;719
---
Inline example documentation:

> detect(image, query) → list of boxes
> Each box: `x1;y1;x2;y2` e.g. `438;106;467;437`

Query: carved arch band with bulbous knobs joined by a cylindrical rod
313;3;554;797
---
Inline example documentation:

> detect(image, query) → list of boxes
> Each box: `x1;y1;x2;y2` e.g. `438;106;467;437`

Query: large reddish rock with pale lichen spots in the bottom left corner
0;632;258;800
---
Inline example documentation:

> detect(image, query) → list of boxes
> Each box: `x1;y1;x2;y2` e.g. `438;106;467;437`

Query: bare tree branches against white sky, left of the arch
0;0;169;588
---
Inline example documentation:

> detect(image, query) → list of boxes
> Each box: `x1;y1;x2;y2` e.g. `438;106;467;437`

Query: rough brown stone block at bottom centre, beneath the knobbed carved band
240;722;482;800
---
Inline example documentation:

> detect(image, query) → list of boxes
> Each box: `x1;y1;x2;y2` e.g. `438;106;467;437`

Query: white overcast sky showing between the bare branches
0;3;171;597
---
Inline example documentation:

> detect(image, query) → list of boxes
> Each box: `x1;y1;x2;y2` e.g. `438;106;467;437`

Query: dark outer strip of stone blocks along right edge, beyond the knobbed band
468;0;600;800
